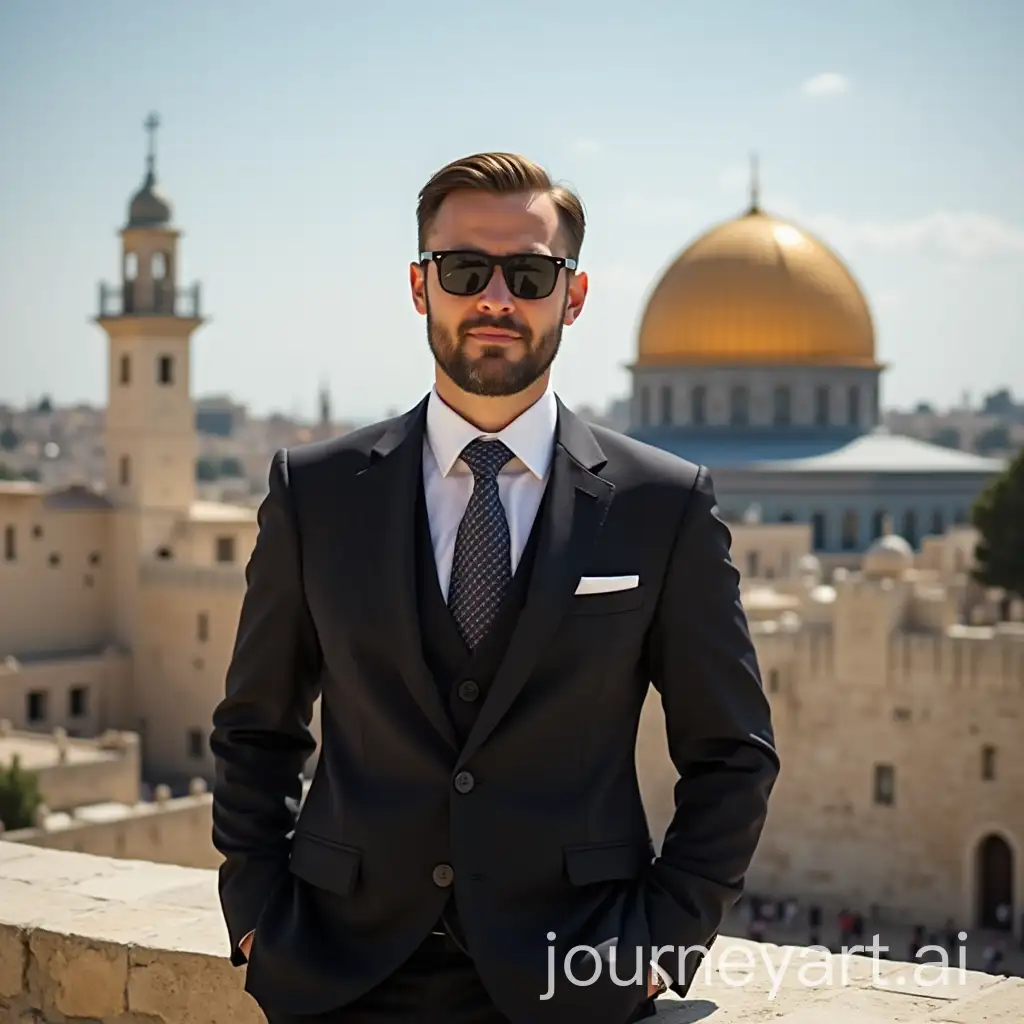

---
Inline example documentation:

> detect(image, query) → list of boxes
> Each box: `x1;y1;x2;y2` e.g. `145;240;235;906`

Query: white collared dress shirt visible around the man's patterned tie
423;388;558;601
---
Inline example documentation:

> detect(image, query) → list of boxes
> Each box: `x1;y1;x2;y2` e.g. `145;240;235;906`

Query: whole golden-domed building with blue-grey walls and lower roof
629;169;1004;555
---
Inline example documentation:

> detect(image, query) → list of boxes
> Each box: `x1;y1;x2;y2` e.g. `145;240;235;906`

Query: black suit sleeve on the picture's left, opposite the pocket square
210;451;322;967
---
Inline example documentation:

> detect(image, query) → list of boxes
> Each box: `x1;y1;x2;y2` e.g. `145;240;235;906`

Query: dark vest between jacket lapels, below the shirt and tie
416;478;550;743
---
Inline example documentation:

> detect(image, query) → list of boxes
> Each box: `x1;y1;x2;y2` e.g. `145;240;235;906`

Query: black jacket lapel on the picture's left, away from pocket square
352;398;458;749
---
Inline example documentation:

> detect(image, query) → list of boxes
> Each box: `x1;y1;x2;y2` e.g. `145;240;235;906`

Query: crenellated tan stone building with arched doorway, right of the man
637;524;1024;941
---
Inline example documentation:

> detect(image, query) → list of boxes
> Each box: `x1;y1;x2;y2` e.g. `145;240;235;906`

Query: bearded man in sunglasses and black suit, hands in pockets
211;154;778;1024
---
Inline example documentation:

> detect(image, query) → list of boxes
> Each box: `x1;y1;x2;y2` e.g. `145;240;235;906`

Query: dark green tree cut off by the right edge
971;447;1024;597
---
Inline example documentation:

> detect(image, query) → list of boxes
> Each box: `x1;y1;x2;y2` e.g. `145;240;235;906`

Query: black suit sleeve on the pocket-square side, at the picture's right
645;467;779;995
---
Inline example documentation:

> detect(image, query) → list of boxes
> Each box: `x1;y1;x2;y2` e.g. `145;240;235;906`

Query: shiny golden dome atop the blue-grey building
636;198;879;368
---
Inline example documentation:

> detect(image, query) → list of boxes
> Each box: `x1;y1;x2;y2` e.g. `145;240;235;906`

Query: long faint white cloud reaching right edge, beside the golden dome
806;210;1024;260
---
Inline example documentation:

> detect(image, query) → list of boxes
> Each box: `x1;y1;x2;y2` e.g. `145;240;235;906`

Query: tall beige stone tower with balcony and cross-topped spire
95;114;204;515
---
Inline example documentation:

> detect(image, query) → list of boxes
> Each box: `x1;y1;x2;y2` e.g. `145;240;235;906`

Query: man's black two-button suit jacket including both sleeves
211;399;779;1024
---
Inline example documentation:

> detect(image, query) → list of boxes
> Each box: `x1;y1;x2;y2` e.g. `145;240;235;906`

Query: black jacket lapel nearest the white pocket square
459;400;614;764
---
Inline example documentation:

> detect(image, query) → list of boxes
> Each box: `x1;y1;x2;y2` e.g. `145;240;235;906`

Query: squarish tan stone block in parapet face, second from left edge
28;929;128;1019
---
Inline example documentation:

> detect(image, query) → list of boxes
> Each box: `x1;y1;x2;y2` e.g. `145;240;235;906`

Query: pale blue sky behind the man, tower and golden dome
0;0;1024;418
